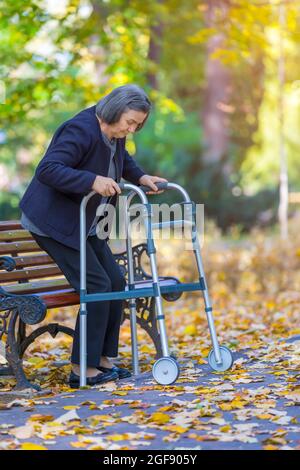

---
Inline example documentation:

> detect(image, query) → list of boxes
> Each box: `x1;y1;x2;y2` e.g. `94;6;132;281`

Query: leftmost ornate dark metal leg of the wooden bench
6;310;41;390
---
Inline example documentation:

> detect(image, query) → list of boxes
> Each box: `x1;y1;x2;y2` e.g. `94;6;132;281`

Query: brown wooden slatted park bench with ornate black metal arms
0;221;181;390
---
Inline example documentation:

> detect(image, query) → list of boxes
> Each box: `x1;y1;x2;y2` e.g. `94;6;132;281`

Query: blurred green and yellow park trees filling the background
0;0;300;230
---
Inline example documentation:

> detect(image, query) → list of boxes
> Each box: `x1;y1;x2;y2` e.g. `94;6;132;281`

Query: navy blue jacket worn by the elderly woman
19;106;145;250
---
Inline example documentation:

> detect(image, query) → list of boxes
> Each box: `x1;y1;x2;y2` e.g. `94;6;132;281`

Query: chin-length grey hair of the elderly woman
96;85;151;132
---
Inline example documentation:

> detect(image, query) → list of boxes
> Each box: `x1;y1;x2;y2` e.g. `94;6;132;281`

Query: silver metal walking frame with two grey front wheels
80;182;233;387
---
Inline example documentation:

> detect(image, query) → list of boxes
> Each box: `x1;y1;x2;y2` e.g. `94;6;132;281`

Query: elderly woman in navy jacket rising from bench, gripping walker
20;85;166;388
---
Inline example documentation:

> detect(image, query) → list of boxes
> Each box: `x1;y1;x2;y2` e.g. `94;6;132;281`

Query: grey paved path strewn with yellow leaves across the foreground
0;337;300;450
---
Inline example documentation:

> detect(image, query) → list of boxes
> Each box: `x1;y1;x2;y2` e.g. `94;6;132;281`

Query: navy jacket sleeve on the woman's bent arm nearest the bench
35;123;97;193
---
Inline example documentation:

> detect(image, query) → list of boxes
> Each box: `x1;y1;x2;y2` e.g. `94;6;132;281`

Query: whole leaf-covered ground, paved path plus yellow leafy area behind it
0;229;300;450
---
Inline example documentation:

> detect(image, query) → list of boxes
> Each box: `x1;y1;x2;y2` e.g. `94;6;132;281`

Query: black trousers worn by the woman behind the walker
31;233;126;367
